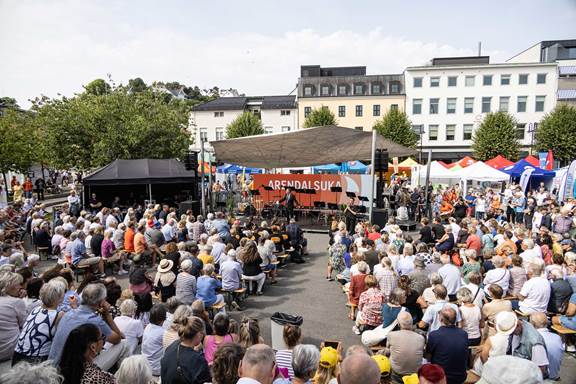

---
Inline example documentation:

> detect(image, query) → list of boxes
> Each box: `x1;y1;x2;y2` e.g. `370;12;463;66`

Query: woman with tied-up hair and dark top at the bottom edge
160;316;212;384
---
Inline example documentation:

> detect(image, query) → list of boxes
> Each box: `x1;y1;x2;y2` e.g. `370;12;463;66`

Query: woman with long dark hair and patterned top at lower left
57;323;116;384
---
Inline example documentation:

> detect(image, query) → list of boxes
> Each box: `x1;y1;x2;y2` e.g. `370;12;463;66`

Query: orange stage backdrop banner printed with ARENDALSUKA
252;174;372;206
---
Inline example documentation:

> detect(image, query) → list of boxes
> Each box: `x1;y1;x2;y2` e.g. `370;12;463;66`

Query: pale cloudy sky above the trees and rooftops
0;0;576;108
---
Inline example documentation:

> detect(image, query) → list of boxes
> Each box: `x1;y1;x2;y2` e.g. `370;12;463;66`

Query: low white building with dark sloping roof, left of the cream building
189;96;298;147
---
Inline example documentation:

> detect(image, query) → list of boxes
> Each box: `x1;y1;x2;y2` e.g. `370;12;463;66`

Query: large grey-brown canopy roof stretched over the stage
210;125;416;168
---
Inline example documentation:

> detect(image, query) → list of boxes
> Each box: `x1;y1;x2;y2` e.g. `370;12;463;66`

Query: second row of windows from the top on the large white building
412;96;546;115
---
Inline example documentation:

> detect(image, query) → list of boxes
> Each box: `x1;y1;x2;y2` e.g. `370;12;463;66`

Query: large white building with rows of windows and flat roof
404;56;558;160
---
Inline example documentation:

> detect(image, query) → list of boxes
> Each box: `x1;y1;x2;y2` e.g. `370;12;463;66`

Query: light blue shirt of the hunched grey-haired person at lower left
48;305;112;365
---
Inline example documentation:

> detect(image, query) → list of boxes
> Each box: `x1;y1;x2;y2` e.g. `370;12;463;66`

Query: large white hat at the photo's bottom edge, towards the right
477;356;544;384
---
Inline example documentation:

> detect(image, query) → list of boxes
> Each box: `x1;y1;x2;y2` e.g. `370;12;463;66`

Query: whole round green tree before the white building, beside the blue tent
472;112;520;161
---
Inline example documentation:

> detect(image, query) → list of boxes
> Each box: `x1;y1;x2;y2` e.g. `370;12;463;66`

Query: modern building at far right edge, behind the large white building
507;39;576;105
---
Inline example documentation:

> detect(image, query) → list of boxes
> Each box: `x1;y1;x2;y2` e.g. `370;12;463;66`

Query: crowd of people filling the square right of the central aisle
326;183;576;383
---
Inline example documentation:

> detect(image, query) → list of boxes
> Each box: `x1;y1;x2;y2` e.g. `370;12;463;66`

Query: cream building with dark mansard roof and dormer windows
298;65;405;131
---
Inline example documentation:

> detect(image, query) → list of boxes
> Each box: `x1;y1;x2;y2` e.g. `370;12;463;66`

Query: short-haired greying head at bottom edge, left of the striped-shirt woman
237;344;276;384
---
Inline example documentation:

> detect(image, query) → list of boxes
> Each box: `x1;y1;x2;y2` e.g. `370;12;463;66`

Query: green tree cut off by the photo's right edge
534;104;576;162
